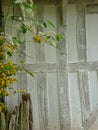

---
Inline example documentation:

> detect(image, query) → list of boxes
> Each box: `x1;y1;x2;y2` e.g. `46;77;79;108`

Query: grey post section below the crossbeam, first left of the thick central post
37;73;49;130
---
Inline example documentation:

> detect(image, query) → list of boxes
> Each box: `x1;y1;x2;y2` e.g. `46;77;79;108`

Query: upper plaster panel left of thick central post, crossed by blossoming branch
43;5;56;62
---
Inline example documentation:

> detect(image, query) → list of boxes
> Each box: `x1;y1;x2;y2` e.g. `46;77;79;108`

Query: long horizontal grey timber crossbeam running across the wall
24;61;98;73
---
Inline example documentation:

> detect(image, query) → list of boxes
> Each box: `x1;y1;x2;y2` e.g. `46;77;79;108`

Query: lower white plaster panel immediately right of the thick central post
69;72;82;130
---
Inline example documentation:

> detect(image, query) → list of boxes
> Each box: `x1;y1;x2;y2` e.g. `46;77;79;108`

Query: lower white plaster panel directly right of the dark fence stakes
27;75;39;130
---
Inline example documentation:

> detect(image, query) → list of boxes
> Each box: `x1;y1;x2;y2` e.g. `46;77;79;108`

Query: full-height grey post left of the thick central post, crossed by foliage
35;5;49;130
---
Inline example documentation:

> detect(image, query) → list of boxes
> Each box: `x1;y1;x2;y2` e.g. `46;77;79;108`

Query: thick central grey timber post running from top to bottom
57;0;71;130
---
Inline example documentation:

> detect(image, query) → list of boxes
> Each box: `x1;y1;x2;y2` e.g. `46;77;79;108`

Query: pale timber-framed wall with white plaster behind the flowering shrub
3;0;98;130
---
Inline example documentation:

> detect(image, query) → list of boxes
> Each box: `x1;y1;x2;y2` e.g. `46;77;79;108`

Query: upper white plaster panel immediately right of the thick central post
67;5;78;62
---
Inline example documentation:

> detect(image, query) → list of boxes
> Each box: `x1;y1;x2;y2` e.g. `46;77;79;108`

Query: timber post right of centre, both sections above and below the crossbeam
76;1;90;125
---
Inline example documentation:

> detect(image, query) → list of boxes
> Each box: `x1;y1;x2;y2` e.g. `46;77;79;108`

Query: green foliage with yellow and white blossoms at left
0;0;62;112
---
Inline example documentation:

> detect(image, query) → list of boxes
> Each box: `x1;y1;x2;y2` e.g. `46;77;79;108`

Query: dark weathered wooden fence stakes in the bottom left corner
0;93;33;130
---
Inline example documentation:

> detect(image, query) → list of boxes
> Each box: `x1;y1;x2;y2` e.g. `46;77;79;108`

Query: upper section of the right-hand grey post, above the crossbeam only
76;1;87;61
